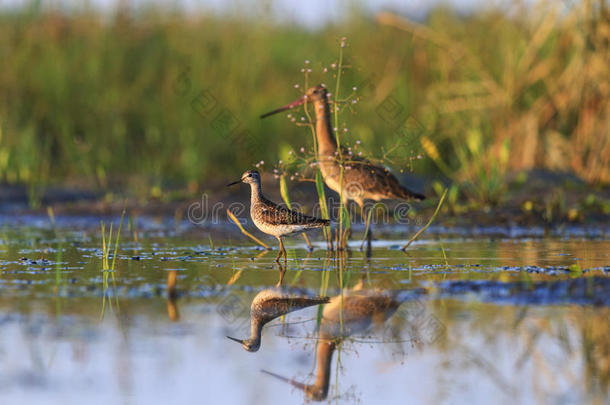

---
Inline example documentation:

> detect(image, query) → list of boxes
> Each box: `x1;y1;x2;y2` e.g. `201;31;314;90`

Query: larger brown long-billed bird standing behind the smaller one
261;85;426;245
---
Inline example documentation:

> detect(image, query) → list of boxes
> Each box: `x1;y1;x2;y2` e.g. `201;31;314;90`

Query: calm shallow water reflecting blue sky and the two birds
0;221;610;404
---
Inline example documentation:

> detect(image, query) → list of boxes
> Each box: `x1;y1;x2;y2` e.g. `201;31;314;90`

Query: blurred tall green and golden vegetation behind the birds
0;1;610;204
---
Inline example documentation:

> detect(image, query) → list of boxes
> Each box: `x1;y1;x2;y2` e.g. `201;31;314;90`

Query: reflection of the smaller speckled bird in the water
227;288;329;352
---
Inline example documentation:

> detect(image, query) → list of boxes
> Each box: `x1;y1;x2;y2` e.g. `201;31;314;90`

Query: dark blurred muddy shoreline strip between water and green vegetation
0;174;610;235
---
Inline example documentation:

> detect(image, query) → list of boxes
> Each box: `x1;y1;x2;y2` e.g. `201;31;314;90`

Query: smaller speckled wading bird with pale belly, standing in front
227;170;330;262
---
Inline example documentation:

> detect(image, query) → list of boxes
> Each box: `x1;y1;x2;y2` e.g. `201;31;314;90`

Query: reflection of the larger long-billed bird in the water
263;290;402;401
